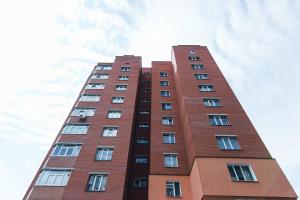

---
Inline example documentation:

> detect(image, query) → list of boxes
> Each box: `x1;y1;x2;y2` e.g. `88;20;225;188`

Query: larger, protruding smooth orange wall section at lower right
191;158;297;200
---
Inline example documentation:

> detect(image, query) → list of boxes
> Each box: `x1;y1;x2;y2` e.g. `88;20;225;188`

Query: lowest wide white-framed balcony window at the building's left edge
36;169;71;186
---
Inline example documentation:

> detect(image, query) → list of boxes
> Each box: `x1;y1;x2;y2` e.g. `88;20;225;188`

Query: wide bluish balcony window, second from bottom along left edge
52;144;81;157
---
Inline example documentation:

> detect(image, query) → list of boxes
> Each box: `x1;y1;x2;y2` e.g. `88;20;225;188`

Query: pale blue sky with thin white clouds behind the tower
0;0;300;199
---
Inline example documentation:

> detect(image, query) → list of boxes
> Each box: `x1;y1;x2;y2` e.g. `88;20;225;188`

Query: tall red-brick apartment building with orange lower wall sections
24;45;297;200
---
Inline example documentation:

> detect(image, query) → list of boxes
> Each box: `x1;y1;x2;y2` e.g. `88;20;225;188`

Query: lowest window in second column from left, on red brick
87;174;107;192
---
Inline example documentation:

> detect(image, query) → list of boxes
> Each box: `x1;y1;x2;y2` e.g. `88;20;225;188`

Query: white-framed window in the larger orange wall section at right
227;164;257;181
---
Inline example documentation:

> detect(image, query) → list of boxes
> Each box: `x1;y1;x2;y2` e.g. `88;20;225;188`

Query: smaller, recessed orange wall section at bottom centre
148;175;193;200
